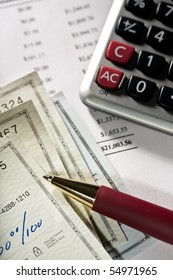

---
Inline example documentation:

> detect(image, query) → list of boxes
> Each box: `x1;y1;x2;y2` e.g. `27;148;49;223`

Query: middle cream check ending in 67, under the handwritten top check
0;100;93;228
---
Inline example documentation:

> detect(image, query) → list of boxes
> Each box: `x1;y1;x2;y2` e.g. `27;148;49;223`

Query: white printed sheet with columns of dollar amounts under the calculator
0;0;173;259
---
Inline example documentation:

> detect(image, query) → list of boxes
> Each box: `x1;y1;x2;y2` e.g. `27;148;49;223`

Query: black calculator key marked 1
137;51;166;77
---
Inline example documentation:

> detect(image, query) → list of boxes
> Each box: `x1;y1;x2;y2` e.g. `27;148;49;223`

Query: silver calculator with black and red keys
80;0;173;135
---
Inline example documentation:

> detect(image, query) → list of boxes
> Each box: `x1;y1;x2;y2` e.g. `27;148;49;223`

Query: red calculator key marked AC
97;66;124;89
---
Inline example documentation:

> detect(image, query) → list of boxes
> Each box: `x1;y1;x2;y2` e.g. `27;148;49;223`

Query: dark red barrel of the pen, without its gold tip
92;186;173;244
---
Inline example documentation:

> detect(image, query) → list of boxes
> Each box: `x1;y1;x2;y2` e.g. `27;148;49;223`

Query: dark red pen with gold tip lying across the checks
43;175;173;244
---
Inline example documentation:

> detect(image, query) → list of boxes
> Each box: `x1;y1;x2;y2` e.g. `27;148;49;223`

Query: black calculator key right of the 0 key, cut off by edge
158;86;173;110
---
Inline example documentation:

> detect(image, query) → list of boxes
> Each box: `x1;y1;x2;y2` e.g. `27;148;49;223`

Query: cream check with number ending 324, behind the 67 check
0;72;123;244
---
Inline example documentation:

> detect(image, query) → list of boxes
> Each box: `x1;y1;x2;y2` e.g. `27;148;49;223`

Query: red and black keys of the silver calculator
101;0;173;110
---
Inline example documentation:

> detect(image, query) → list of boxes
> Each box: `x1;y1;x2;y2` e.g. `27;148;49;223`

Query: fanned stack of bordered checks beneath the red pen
0;72;151;260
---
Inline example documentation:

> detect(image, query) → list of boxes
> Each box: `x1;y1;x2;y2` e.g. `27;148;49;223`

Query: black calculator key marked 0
127;76;156;101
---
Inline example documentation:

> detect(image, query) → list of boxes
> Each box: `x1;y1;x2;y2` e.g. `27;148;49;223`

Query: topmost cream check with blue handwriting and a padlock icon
0;133;110;260
